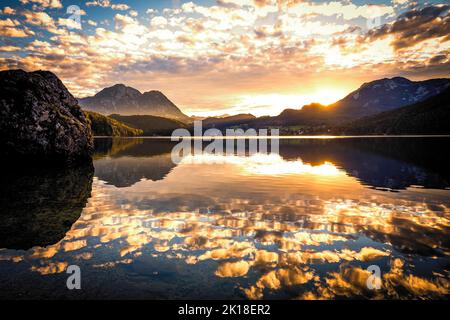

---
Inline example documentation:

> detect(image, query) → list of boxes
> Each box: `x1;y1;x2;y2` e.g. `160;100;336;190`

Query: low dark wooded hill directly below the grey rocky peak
110;114;187;136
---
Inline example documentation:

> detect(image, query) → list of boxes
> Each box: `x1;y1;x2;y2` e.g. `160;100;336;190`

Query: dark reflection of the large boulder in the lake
0;164;94;249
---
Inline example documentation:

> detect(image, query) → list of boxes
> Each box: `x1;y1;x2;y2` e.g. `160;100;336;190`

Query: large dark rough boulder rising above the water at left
0;70;93;162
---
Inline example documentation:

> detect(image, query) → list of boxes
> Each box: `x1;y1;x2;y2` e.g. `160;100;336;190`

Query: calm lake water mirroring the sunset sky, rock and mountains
0;138;450;299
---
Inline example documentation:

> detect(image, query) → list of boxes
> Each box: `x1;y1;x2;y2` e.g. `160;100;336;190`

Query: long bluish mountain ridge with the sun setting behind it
197;77;450;134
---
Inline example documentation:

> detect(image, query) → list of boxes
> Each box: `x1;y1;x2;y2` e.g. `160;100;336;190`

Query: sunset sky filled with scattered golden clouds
0;0;450;116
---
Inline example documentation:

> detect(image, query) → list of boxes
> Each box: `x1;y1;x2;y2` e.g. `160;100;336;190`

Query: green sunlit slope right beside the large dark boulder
84;111;143;137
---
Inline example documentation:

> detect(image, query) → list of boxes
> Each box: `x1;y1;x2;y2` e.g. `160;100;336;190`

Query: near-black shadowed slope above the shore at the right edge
332;88;450;134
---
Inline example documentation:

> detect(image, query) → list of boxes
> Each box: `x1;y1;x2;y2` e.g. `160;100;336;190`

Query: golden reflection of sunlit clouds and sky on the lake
0;138;450;299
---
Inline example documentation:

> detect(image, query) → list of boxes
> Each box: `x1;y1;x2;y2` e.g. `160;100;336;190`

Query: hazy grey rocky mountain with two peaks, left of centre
79;84;189;122
